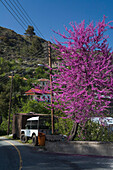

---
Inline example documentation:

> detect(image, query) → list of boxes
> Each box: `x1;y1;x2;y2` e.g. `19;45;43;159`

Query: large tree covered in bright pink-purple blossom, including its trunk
52;17;113;140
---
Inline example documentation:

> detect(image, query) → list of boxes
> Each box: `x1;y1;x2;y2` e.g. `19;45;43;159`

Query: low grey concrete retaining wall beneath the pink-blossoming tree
45;141;113;156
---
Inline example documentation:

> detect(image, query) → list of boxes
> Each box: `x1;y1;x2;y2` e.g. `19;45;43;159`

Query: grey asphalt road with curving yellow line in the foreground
0;137;113;170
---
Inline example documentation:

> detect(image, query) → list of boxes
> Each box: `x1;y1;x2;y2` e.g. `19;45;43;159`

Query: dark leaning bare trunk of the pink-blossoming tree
69;123;78;141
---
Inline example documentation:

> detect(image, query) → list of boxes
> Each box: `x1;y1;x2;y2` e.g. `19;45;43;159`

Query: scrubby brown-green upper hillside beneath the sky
0;27;55;69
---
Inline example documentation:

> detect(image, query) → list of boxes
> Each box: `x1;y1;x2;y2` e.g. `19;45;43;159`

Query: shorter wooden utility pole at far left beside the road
7;72;14;135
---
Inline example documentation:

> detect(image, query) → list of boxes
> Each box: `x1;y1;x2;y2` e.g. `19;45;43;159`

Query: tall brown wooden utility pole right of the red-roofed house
48;41;54;134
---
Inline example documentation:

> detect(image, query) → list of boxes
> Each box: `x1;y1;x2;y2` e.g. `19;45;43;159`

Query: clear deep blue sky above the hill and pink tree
0;0;113;49
